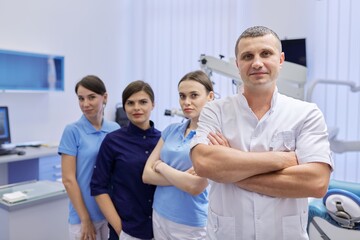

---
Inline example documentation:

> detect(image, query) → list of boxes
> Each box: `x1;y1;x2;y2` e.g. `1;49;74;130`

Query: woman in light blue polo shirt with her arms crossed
143;71;214;240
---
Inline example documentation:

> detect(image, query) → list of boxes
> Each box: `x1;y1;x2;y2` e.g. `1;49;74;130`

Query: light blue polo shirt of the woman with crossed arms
154;120;208;234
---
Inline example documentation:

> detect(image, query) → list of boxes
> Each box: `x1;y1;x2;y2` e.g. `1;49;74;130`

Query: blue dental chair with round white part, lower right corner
308;180;360;240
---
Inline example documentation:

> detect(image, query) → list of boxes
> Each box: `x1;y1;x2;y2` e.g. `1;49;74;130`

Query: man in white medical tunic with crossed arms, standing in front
191;26;332;240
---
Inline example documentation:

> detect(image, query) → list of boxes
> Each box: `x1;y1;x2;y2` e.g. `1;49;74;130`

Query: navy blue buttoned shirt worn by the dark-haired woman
91;121;161;239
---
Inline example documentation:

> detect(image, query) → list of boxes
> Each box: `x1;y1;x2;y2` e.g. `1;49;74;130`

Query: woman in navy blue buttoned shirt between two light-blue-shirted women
91;80;160;240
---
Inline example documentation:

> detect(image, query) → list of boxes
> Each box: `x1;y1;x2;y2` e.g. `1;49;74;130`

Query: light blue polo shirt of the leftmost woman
58;115;120;224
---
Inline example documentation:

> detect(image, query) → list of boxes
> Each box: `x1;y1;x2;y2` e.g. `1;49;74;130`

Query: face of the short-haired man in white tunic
236;34;285;89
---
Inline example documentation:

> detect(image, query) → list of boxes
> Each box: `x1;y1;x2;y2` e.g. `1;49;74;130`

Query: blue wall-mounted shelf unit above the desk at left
0;50;64;91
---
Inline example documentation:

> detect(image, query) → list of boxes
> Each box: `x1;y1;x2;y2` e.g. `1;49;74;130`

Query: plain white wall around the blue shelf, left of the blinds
0;0;123;143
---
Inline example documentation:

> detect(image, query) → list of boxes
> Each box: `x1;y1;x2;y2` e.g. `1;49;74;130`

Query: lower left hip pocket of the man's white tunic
206;208;235;240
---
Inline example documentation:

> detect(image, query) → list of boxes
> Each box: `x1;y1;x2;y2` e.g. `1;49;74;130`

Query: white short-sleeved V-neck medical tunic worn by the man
191;89;332;240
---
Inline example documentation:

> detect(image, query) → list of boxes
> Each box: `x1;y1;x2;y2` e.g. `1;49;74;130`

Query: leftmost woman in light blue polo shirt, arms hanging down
58;75;119;240
